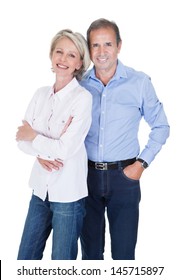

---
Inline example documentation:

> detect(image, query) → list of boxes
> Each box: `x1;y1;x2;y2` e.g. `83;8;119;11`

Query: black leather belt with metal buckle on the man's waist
88;158;136;170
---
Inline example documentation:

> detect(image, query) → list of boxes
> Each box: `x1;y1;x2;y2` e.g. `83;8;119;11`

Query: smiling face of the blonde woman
51;37;82;78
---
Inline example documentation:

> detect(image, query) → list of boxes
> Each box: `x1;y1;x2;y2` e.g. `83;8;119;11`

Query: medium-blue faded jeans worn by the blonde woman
18;195;85;260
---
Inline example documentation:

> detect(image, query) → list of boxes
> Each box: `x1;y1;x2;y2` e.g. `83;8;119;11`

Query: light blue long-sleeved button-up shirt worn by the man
80;60;169;164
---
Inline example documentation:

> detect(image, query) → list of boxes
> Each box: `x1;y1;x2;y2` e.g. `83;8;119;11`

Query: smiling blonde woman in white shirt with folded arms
16;29;92;260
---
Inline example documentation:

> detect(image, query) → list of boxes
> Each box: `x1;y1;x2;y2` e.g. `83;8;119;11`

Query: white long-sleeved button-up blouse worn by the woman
18;78;92;202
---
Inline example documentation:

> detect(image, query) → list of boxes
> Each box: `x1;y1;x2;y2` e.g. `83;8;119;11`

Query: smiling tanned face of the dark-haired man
90;28;121;72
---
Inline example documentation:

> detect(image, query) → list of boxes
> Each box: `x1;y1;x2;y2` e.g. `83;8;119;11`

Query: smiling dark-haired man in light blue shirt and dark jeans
81;19;169;260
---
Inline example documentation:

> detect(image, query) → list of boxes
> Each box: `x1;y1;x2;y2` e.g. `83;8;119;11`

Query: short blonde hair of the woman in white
49;29;91;80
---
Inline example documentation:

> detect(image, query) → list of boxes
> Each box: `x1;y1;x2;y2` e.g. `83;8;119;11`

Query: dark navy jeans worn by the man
80;166;141;260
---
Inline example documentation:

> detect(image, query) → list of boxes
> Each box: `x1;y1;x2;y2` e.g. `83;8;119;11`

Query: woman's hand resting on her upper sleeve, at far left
16;121;37;141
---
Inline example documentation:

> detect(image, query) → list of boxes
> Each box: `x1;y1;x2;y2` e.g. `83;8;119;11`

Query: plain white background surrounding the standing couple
0;0;180;278
